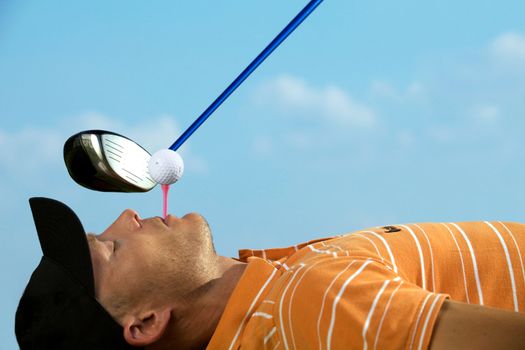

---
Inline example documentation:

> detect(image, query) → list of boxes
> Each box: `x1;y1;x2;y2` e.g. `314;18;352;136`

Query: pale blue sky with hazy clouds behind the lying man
0;0;525;349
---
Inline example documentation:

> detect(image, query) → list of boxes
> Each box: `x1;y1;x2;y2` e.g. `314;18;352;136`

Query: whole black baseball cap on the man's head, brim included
15;198;137;350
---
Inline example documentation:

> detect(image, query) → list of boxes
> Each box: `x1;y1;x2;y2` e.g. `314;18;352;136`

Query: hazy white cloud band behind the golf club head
0;112;208;178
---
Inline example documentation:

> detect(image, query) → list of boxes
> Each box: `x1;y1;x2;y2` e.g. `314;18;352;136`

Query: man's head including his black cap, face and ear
15;198;216;349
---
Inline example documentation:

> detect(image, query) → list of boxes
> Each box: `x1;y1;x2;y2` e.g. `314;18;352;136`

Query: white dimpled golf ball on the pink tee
148;149;184;185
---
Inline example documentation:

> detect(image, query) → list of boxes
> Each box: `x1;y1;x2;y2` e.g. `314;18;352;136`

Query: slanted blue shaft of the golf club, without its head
170;0;323;151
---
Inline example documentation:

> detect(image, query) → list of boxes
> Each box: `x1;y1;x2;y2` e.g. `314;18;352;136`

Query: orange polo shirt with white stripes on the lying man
208;222;525;350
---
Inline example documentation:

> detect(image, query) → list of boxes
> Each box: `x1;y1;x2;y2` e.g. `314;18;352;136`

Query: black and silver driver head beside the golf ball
64;130;156;192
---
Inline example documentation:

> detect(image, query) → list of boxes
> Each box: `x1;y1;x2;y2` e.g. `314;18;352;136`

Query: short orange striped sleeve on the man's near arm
273;257;448;349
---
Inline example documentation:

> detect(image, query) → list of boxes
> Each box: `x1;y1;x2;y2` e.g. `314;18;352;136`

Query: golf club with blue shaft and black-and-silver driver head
64;0;323;192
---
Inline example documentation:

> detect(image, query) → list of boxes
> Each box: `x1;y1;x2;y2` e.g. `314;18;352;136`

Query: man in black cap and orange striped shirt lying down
16;198;525;349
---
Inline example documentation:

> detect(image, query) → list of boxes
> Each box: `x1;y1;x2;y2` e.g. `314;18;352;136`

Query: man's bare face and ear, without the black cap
88;209;218;345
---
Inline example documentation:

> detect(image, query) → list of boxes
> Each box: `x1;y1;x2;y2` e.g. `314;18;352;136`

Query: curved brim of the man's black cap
29;197;95;297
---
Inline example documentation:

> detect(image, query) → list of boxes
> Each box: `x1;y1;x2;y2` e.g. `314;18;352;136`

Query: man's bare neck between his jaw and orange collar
159;257;246;349
